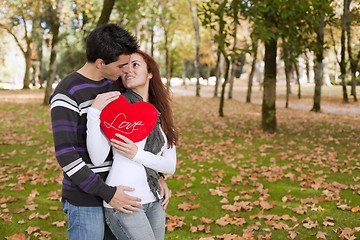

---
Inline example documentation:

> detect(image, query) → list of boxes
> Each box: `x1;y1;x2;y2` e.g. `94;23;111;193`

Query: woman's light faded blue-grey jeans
104;201;165;240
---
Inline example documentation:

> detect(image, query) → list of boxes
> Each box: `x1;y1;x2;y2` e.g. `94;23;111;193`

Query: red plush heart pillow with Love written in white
100;96;158;142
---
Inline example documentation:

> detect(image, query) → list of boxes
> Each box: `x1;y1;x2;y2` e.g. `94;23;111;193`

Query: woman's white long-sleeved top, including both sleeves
86;107;176;208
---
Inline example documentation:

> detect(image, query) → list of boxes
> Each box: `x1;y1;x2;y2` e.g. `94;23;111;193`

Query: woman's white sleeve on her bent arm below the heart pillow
132;143;176;174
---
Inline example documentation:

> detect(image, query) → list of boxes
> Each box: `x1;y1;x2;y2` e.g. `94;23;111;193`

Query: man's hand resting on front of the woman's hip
109;186;141;214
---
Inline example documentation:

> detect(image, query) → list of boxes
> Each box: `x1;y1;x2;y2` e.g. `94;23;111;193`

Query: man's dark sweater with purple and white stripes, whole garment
50;72;119;206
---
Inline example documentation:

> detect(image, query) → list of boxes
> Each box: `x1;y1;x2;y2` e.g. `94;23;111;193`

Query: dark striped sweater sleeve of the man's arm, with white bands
50;89;116;202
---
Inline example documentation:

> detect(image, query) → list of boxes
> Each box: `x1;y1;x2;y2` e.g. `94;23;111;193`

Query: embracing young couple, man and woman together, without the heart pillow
50;24;177;240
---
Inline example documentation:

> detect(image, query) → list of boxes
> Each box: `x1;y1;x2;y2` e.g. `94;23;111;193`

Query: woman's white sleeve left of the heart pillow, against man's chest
86;107;110;166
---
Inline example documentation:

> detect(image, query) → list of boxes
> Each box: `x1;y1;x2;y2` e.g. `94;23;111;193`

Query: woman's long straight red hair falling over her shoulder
118;50;178;147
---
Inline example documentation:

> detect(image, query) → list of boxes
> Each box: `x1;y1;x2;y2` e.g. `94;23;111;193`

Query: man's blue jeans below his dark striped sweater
62;201;116;240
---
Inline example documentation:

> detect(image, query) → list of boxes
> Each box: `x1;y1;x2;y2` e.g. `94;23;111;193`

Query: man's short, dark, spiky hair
86;24;139;64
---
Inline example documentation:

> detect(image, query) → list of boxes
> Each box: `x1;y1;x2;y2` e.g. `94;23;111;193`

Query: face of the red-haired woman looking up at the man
121;53;152;91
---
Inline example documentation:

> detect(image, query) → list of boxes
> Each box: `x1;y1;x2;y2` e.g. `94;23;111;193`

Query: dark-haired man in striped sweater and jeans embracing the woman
50;24;169;240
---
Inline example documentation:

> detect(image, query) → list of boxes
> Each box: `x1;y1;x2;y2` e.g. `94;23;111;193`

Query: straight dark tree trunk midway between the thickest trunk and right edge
311;16;324;112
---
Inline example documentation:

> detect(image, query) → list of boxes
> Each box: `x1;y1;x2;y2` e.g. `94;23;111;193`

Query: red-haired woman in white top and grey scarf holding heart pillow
87;50;177;240
